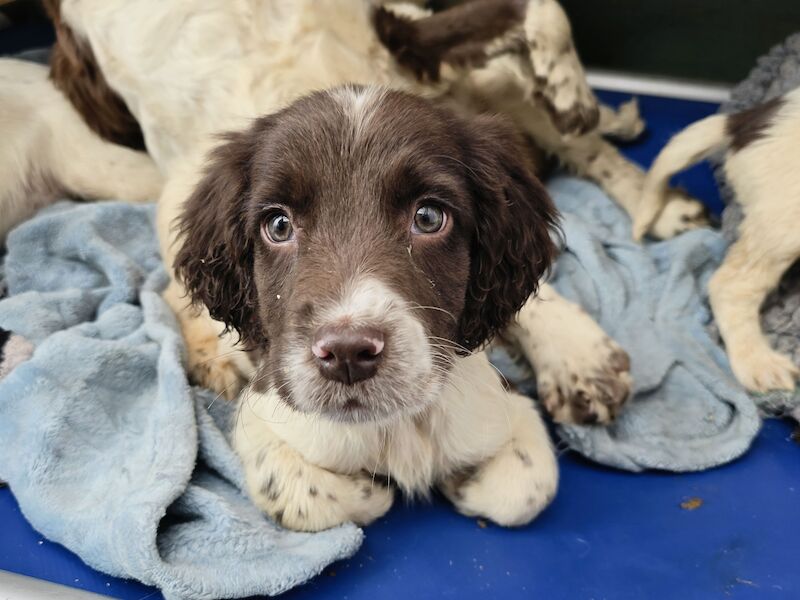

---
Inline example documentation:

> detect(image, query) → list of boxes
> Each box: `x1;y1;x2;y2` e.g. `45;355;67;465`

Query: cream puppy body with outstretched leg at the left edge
0;59;161;241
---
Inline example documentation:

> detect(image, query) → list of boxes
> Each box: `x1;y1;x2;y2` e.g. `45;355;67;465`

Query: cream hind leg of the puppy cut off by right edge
709;218;800;392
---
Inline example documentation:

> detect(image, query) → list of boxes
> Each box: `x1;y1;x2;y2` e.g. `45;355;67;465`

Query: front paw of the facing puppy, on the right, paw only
440;439;558;527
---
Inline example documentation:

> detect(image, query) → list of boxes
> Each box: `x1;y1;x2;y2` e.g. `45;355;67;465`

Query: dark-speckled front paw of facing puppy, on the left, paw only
245;446;394;531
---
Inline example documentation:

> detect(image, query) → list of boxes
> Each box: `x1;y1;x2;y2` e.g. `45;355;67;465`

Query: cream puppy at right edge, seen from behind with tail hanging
634;84;800;392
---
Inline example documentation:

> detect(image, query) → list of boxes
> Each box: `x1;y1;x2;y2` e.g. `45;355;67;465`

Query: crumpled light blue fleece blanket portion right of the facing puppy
493;177;760;471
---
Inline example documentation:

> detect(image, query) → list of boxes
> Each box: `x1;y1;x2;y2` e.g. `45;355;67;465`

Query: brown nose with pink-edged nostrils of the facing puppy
311;325;383;385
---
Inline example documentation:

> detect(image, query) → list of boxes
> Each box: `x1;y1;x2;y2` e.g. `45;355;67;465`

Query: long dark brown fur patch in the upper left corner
43;0;144;150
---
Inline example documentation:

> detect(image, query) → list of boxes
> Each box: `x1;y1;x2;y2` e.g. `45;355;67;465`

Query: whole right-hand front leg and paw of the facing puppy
440;393;558;527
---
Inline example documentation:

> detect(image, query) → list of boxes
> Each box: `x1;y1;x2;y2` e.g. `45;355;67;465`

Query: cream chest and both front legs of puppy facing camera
234;353;558;530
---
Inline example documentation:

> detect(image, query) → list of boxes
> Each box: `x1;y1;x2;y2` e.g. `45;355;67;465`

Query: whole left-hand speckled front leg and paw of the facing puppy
233;390;394;531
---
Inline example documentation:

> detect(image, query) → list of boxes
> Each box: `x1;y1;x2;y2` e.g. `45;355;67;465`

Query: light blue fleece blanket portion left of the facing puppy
0;203;362;599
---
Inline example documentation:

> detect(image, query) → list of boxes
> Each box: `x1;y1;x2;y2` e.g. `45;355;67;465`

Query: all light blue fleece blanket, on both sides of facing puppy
0;178;759;598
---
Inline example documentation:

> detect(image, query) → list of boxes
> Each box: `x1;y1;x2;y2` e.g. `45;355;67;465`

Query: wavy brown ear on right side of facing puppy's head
461;116;558;350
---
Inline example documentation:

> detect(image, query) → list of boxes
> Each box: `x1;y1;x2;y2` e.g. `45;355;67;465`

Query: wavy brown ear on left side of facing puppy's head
174;123;262;346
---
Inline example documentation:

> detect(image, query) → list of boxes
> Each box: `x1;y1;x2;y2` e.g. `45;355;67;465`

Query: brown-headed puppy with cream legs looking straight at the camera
176;86;558;531
